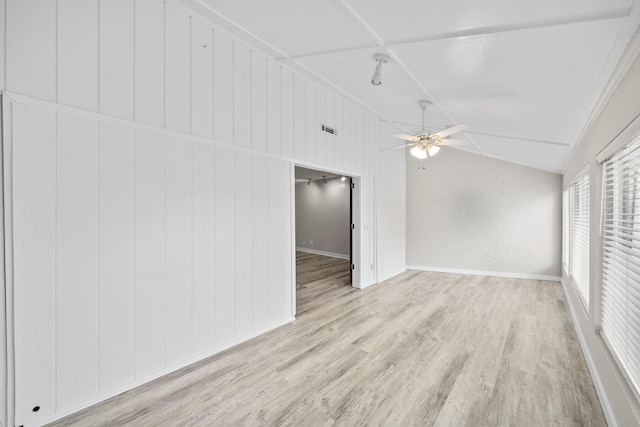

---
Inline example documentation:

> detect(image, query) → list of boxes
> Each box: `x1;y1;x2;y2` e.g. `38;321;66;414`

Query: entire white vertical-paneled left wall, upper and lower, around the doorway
5;0;405;425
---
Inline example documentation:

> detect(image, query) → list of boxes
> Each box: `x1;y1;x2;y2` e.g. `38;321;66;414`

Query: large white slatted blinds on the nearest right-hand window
601;139;640;400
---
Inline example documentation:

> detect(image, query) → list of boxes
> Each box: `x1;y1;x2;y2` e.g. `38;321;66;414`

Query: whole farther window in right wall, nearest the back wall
562;172;590;308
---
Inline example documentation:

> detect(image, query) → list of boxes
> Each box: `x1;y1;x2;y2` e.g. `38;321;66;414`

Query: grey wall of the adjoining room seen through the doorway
296;178;351;257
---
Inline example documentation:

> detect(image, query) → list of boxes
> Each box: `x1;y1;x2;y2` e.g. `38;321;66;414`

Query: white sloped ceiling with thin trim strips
181;0;640;172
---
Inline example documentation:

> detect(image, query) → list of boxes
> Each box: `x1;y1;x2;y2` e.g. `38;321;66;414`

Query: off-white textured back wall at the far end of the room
407;149;562;276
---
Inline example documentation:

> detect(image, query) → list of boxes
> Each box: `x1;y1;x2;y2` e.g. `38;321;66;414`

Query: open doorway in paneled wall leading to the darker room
293;166;360;315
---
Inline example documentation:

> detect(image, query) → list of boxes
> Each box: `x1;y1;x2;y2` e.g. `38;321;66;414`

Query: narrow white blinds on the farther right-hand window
568;173;589;308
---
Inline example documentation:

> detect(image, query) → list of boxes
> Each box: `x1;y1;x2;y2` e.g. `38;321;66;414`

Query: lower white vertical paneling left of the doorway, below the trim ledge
13;105;292;424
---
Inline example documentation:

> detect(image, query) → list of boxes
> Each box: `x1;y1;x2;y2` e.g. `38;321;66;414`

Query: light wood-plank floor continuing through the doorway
50;253;606;426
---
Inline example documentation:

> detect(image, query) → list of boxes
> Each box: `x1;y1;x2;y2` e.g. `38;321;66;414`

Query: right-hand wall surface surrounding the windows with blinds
562;34;640;426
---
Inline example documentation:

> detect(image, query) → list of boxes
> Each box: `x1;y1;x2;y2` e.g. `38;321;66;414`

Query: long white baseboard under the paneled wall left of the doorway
42;316;296;425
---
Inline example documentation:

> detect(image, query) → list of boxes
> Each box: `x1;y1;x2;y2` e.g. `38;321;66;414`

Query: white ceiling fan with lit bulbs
380;100;468;159
